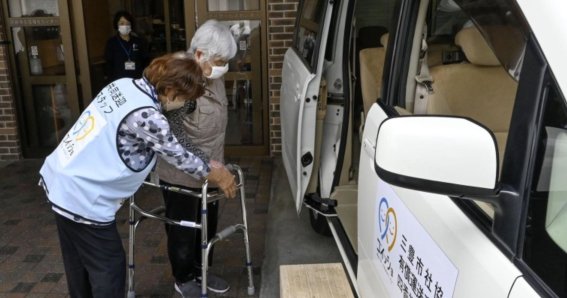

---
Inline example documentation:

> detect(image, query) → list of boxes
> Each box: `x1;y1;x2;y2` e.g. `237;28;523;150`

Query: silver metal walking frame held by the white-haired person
128;164;255;298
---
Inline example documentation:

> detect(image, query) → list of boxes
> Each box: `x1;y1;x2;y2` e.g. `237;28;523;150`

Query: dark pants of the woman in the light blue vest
55;214;126;298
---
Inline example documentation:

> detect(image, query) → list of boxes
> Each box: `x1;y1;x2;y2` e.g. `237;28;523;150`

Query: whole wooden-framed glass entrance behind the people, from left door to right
1;0;269;158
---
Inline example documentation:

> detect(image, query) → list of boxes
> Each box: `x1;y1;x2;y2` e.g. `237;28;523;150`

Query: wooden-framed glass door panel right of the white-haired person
196;0;268;154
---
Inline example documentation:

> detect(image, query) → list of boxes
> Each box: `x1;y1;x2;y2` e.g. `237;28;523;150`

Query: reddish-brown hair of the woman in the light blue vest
144;52;205;100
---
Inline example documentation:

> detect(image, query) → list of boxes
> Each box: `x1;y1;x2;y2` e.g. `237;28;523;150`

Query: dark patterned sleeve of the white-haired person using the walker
165;100;210;164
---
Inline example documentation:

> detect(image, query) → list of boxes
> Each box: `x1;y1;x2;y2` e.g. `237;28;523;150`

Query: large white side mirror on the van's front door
374;116;498;196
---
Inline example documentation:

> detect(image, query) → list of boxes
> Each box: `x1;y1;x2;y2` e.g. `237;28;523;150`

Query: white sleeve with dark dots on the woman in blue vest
118;108;210;179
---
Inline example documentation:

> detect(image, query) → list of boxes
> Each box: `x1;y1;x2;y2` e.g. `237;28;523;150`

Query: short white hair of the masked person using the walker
189;20;237;60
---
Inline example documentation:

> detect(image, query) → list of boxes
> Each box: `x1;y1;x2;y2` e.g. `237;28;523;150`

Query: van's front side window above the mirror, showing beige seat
422;0;525;221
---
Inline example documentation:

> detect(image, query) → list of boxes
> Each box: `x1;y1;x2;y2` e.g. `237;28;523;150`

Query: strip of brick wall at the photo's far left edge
0;16;22;160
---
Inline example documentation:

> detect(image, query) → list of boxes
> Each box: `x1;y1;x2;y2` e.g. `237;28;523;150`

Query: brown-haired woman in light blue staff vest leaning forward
40;53;236;297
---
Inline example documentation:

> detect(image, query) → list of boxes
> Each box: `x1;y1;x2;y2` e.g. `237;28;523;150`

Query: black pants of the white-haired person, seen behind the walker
160;181;219;283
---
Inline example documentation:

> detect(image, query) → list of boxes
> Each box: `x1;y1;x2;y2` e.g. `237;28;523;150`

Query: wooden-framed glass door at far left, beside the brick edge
2;0;81;157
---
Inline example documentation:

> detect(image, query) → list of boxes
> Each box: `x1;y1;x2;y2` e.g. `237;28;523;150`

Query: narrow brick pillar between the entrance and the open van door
267;0;299;156
